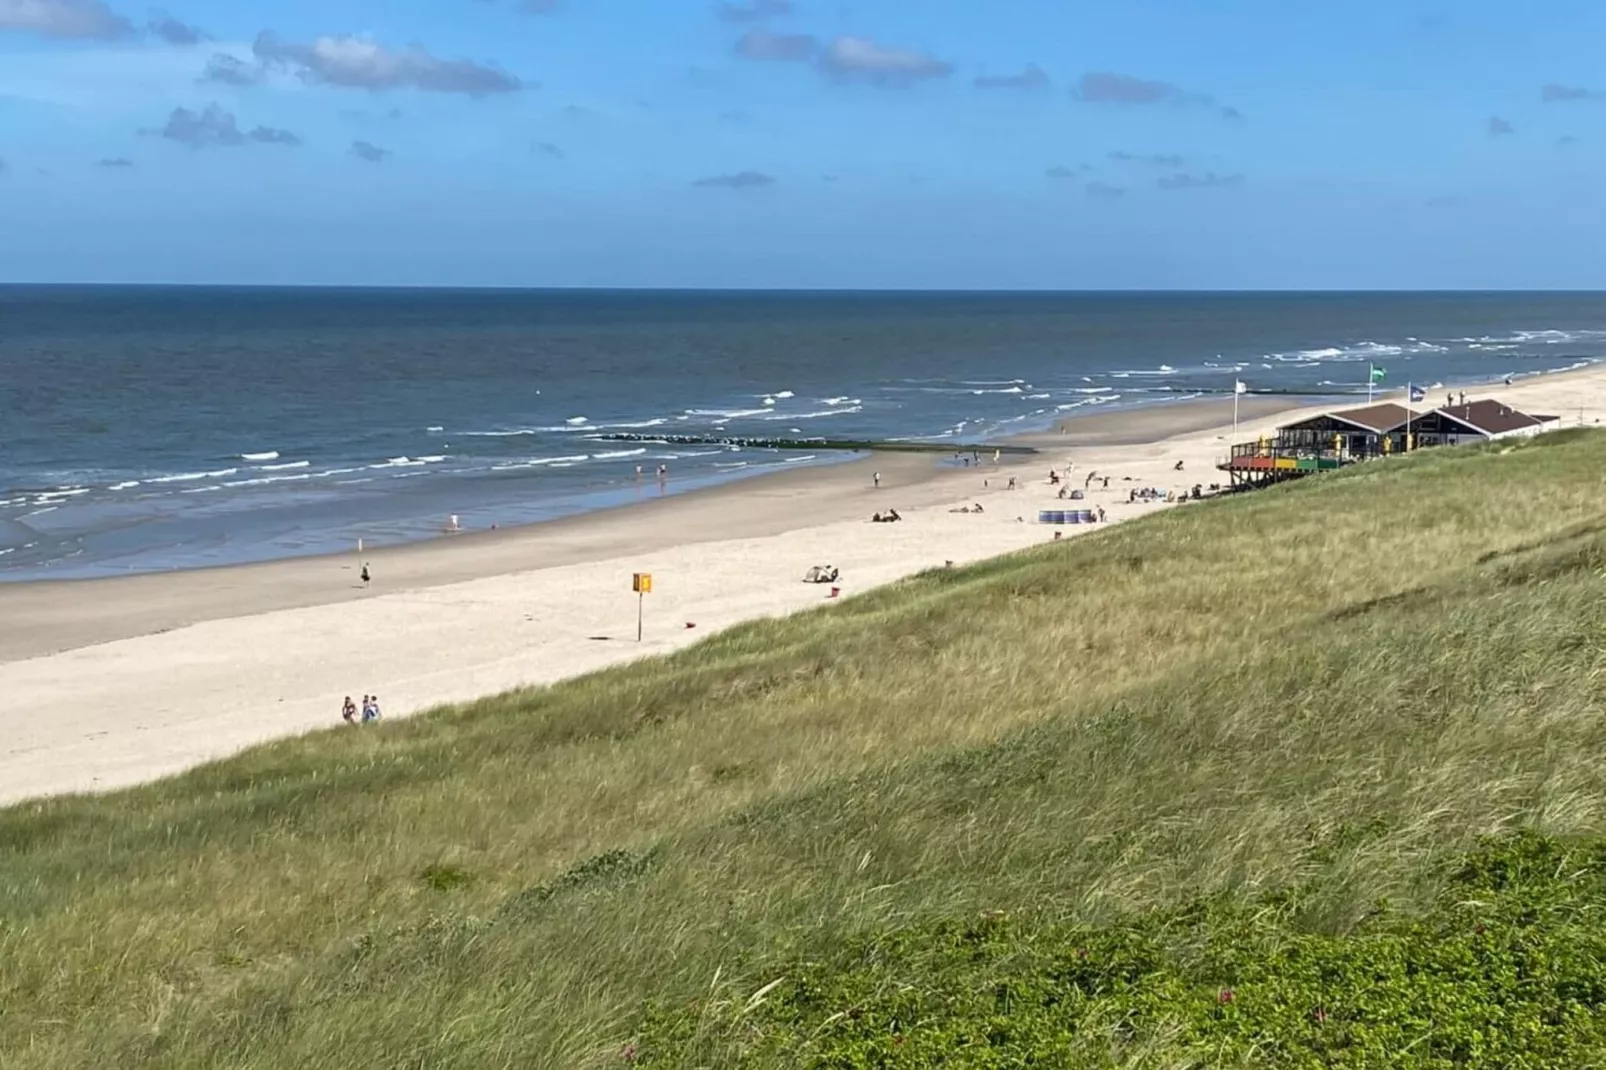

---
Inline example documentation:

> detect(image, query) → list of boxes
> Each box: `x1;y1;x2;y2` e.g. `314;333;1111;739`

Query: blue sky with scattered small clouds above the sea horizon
0;0;1606;289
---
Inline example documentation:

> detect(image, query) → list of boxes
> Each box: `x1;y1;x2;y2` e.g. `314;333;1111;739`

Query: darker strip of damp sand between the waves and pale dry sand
0;387;1307;664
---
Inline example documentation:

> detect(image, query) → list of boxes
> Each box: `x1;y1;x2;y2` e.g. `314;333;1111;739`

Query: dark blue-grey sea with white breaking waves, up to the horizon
0;286;1606;580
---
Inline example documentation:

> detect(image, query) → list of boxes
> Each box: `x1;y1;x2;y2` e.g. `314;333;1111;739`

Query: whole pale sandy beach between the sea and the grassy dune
0;368;1606;802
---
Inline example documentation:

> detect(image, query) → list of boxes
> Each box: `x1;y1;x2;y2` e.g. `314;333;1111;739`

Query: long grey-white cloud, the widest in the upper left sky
252;31;524;96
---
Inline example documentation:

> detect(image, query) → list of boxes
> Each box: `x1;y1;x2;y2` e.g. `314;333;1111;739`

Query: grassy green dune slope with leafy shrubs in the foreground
0;432;1606;1070
